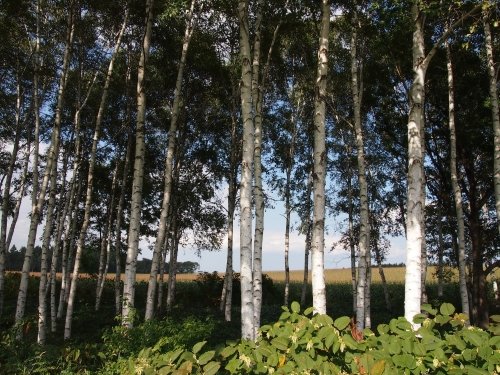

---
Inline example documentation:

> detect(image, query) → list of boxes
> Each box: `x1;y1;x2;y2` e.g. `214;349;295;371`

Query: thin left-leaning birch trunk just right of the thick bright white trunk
448;43;470;314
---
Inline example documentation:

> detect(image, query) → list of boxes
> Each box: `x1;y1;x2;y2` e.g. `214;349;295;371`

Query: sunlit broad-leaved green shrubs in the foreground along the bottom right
128;302;500;375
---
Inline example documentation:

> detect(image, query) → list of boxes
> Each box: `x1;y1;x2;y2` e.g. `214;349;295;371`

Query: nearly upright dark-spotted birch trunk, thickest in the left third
122;0;154;328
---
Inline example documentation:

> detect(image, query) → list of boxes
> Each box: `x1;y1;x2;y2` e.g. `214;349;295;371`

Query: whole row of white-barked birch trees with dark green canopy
0;0;500;344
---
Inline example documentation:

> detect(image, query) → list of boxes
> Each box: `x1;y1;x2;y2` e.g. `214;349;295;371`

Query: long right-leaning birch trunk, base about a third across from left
145;0;196;320
